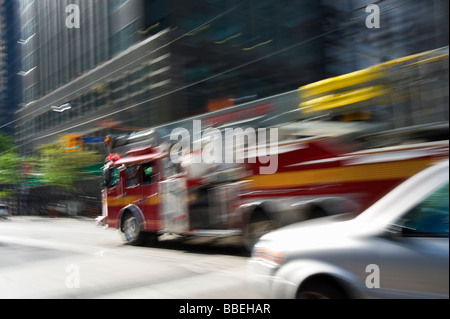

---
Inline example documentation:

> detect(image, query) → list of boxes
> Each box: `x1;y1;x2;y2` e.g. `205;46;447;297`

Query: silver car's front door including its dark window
378;181;449;298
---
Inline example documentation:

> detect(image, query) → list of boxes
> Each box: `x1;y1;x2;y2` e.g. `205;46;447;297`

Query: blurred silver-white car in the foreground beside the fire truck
248;160;449;299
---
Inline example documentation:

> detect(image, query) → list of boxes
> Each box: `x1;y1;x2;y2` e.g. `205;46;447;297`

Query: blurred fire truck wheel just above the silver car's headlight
243;209;278;251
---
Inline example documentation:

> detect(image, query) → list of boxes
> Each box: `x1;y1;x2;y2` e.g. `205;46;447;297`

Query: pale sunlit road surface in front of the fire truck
0;217;261;299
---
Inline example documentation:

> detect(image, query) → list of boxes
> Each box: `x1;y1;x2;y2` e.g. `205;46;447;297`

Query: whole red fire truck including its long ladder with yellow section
96;47;448;248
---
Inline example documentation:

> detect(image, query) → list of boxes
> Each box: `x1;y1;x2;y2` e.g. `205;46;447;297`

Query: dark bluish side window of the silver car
396;182;449;237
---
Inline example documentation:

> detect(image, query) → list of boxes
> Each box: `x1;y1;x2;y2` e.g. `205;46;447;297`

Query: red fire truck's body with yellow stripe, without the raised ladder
103;129;448;247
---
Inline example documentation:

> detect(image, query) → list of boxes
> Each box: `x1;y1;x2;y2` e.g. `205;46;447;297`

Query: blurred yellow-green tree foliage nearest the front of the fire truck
36;144;101;189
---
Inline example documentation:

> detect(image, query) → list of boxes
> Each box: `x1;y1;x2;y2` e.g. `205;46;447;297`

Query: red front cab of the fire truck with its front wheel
103;147;190;245
